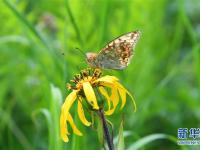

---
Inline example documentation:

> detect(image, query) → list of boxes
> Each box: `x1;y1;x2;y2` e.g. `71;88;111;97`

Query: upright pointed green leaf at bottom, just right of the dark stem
117;120;125;150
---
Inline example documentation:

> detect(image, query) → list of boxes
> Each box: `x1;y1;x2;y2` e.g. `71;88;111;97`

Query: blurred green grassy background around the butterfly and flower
0;0;200;150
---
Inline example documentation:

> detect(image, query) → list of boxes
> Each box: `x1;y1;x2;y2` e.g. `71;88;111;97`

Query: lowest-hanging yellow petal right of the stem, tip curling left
105;86;119;115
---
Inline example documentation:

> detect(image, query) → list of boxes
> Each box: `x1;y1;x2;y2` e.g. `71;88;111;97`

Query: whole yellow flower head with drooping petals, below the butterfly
60;69;136;142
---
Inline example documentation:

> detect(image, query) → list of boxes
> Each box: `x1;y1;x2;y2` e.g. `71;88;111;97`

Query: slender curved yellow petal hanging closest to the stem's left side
78;97;91;126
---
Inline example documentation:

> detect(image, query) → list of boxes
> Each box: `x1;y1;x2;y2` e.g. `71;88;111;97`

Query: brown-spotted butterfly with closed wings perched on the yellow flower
86;31;140;70
